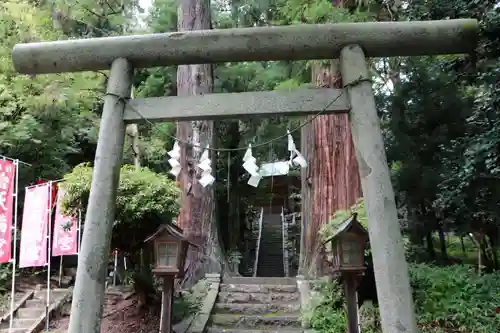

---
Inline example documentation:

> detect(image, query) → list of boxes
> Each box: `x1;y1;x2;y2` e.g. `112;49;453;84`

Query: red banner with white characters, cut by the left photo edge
0;160;15;264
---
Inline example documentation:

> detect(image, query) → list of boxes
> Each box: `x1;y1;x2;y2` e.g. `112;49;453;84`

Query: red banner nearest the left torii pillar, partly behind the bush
52;187;78;257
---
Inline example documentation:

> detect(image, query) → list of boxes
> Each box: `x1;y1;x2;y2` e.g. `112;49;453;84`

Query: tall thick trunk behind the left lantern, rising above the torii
177;0;222;286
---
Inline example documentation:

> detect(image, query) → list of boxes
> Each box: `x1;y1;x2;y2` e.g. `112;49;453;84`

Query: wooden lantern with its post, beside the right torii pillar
325;213;368;333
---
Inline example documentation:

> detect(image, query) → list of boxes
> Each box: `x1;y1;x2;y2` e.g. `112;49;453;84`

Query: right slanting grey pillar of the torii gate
340;45;418;333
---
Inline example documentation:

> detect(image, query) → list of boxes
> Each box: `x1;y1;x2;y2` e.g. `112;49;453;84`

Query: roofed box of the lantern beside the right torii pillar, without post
324;213;368;272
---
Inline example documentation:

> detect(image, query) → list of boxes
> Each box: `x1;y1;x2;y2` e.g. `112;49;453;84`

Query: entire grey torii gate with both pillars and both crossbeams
12;19;478;333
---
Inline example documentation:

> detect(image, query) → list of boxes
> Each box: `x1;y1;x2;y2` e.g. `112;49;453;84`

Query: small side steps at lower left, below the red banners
0;289;70;333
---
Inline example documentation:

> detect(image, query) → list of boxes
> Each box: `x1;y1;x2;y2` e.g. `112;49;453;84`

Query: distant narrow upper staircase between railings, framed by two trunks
257;214;285;277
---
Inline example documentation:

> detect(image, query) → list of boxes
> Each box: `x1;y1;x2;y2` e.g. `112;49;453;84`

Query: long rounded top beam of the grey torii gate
12;19;478;74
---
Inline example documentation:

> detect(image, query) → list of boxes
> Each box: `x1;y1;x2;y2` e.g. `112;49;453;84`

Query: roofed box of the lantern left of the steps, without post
145;224;198;278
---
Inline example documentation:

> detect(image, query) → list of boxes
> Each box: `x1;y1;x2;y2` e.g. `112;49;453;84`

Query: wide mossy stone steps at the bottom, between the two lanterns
207;277;302;333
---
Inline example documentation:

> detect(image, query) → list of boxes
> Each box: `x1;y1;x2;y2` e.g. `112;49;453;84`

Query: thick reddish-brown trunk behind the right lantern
301;60;362;275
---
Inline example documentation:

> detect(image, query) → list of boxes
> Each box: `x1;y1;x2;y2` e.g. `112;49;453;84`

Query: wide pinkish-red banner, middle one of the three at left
19;184;50;268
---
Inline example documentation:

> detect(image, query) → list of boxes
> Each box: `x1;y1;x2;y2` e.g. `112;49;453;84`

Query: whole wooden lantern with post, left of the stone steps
145;224;198;333
